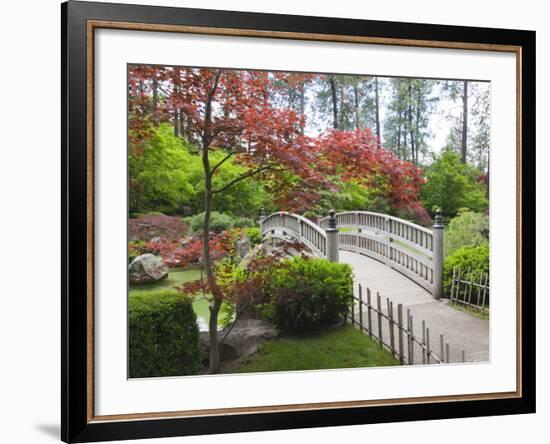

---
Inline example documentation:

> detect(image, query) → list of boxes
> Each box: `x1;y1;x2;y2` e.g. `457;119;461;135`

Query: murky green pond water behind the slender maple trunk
128;267;219;331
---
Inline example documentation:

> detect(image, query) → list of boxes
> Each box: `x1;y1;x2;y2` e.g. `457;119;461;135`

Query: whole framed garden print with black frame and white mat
61;1;535;442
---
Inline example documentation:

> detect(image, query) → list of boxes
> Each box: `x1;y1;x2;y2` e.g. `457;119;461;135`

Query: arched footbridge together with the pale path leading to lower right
260;211;489;364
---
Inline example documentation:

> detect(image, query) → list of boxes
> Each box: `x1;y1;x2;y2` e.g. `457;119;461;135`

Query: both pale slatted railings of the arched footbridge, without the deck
261;211;443;299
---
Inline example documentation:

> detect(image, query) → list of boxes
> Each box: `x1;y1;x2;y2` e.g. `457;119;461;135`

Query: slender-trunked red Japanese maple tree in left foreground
130;67;324;373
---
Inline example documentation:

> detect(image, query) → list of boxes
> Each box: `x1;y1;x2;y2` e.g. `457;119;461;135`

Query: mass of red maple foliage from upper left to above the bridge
129;65;424;216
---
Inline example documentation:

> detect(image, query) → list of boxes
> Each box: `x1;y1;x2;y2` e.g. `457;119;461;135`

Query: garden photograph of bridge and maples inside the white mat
127;64;491;378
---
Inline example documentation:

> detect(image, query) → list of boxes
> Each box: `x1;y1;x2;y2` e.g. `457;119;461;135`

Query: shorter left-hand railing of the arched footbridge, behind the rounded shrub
260;211;327;257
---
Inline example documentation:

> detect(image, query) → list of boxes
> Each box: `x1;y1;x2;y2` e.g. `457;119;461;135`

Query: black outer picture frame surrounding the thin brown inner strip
61;1;535;442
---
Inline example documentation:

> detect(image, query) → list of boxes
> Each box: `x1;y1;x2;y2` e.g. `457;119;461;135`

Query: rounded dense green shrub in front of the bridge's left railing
260;256;353;330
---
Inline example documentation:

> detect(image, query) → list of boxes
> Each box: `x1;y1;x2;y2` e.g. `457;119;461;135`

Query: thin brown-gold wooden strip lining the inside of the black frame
86;20;522;424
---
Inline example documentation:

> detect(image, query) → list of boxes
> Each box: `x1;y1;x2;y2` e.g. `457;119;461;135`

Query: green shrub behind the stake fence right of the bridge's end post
443;243;489;296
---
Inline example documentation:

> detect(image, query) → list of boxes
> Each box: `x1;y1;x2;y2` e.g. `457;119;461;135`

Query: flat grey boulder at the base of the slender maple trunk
200;319;279;361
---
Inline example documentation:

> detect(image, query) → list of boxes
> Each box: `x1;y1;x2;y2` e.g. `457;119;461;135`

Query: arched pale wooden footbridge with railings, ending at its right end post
260;211;443;299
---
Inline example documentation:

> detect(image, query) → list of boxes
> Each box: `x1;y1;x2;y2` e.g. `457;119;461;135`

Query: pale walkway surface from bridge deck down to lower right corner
340;250;489;364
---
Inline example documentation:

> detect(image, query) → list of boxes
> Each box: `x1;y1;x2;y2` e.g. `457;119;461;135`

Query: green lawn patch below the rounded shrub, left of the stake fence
224;326;399;373
